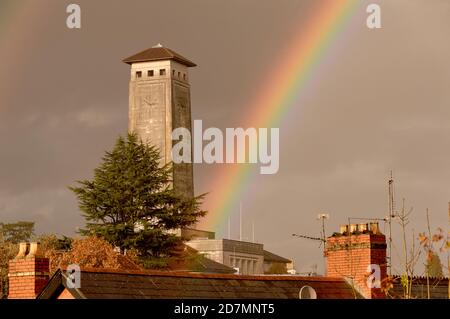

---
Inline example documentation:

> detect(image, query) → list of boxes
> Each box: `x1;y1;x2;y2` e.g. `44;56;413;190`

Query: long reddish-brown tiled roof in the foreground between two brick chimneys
38;269;361;299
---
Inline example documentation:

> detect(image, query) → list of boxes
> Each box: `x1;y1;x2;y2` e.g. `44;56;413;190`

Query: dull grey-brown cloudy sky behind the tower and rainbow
0;0;450;271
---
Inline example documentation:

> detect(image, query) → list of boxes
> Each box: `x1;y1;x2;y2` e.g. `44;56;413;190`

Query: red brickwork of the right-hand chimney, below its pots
326;234;386;298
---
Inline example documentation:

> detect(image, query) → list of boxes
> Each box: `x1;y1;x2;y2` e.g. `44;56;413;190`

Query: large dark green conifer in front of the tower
70;133;206;257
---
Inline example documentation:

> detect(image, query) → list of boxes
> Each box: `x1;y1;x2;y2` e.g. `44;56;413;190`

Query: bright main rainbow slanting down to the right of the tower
197;0;362;235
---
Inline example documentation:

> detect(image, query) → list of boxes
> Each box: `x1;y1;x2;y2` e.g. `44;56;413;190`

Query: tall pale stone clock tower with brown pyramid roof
123;44;196;197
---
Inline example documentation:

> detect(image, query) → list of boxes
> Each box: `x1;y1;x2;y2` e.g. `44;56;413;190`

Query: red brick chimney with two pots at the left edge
8;243;50;299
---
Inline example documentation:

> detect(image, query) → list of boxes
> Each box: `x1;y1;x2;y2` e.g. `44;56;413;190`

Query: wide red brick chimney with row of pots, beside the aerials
325;223;387;299
